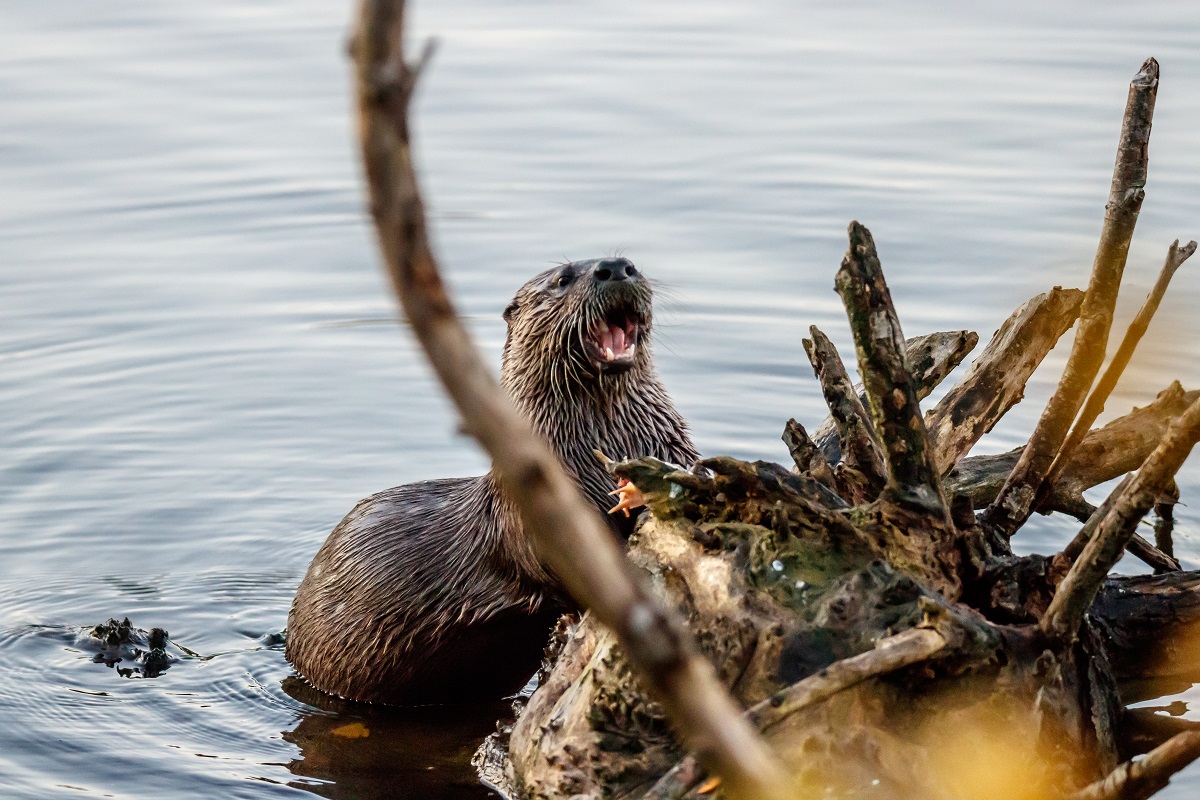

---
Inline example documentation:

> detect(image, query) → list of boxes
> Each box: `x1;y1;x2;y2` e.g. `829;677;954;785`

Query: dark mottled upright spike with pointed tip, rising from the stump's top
834;222;947;516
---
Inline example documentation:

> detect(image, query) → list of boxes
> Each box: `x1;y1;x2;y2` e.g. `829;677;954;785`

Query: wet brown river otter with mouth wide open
287;258;697;705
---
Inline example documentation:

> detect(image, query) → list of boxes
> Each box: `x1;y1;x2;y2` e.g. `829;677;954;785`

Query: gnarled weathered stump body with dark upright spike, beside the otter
512;227;1142;798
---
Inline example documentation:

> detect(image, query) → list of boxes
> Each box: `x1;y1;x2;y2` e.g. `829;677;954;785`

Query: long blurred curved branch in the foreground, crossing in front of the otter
352;6;790;800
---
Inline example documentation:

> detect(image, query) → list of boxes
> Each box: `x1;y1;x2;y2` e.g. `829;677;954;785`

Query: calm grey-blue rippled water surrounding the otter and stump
0;0;1200;798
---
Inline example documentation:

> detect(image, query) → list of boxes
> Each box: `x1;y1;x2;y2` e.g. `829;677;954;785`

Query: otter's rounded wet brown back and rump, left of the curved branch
287;477;559;704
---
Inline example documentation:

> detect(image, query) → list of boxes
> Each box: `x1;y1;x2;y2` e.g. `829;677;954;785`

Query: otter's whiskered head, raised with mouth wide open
502;258;652;396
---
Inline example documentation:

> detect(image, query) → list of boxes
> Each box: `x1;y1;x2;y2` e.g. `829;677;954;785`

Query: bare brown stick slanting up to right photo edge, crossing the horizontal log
1042;401;1200;639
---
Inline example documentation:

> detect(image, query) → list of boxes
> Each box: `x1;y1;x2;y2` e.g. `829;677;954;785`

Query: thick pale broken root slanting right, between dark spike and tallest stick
925;287;1084;474
